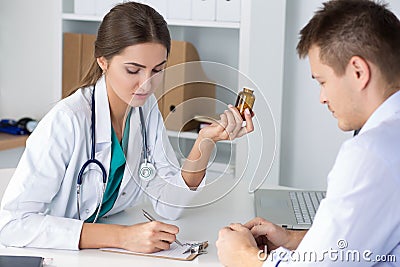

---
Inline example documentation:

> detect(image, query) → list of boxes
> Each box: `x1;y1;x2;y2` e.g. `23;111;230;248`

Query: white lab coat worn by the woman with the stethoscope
0;78;204;250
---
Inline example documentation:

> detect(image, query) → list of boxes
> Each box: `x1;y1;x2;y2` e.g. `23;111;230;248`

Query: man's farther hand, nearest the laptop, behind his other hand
244;217;307;252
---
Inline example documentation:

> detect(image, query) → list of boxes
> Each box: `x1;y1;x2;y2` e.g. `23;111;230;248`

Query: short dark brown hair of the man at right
297;0;400;86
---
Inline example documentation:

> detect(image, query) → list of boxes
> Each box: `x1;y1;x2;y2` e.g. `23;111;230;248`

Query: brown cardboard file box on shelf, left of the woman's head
62;32;96;98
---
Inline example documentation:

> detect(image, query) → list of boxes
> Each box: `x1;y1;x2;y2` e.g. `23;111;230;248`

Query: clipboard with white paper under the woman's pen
100;241;208;261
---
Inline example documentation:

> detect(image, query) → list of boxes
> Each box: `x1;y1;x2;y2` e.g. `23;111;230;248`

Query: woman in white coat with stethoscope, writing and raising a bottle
0;2;253;252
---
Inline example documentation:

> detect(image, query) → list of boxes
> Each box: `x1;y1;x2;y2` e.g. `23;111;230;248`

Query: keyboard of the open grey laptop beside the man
289;191;325;224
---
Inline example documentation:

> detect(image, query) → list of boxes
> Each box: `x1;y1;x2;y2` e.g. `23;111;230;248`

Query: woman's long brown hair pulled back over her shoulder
69;2;171;95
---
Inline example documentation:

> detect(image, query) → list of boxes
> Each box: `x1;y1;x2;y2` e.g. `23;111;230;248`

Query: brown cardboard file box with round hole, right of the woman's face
155;40;216;131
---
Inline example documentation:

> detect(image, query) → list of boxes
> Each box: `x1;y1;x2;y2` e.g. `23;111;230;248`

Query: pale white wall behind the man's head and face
280;0;400;189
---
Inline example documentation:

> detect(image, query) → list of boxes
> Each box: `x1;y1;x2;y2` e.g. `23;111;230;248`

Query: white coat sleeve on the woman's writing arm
0;105;82;250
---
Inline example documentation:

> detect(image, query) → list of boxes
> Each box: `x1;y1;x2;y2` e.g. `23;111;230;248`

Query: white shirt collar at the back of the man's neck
359;91;400;134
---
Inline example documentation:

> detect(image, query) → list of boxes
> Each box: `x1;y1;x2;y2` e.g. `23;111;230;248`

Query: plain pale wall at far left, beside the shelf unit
0;0;61;119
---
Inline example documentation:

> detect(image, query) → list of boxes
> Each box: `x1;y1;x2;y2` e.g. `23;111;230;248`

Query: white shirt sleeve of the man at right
264;141;400;267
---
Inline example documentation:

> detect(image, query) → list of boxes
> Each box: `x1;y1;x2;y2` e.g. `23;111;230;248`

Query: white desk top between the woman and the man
0;169;288;267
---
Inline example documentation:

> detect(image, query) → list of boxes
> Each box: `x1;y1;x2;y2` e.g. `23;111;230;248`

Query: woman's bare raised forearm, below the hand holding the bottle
182;137;215;188
